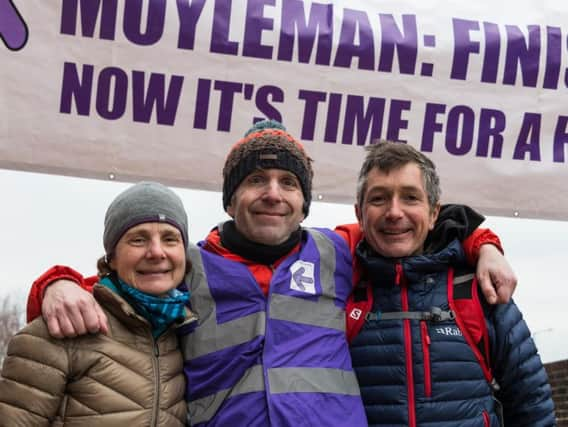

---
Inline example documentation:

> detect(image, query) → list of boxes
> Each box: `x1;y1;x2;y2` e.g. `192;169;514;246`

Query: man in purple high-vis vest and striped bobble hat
25;120;514;427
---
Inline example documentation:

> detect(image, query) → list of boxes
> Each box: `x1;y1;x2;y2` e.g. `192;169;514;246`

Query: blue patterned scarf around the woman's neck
99;274;190;338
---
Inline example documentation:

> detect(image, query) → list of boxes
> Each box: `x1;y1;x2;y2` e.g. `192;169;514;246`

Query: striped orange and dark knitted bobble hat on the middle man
223;120;314;217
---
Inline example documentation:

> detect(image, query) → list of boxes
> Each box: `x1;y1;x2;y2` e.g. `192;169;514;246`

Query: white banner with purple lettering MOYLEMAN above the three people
0;0;568;220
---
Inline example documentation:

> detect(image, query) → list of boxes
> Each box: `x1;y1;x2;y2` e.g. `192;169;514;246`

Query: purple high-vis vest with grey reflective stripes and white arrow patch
181;229;367;427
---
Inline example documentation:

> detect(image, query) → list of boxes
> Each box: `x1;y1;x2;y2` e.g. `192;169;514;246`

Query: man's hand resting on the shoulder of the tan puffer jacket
41;280;108;338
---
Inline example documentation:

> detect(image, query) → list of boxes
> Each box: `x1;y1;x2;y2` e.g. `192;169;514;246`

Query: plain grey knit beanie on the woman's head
103;181;188;255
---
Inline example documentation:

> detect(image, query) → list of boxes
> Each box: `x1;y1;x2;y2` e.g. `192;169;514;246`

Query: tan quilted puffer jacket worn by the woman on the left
0;285;194;427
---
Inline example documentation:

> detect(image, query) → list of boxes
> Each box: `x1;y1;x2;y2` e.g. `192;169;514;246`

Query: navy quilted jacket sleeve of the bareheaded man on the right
489;302;555;427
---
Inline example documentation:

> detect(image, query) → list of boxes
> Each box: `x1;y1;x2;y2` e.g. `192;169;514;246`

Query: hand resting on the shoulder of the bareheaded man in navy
477;244;517;304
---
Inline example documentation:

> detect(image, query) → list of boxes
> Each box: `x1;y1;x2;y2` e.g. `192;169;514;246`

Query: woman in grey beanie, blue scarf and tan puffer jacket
0;182;196;427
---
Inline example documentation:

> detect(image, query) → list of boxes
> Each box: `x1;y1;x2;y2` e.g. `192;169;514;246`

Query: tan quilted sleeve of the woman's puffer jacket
0;318;69;427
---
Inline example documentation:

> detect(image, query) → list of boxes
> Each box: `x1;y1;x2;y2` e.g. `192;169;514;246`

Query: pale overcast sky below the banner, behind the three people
0;169;568;363
